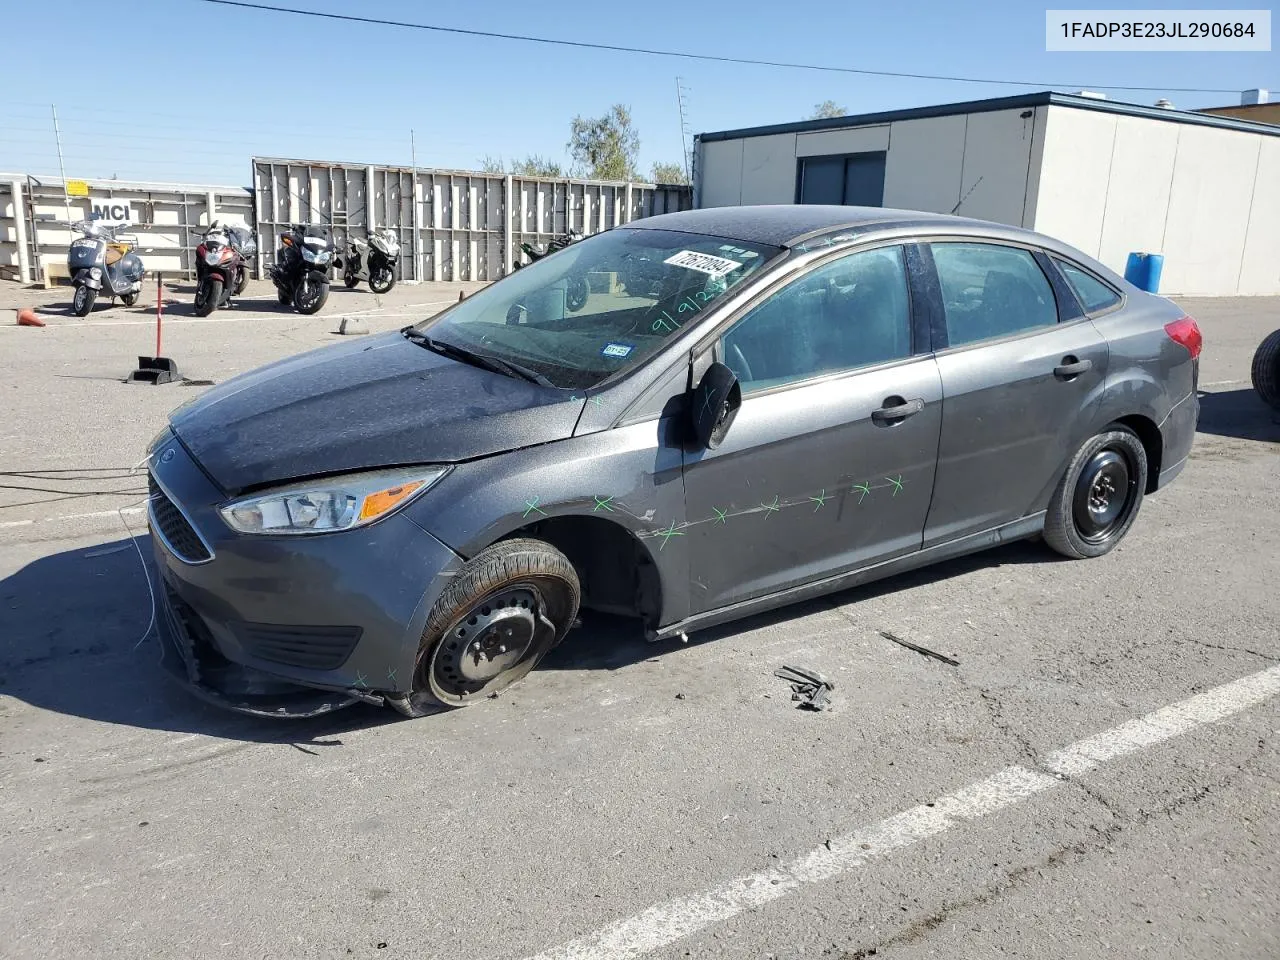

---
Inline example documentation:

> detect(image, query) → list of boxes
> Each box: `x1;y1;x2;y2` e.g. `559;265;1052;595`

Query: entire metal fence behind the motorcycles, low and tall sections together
0;157;692;283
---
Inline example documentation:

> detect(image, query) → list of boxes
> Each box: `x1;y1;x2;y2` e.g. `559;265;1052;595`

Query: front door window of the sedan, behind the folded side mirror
721;247;911;392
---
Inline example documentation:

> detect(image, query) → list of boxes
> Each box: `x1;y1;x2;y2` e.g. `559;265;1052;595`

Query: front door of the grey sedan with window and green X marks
680;246;941;613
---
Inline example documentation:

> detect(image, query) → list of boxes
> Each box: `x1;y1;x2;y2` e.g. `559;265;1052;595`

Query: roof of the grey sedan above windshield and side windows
626;204;1119;282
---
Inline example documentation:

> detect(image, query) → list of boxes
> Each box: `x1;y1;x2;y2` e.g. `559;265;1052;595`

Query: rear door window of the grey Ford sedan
931;243;1057;347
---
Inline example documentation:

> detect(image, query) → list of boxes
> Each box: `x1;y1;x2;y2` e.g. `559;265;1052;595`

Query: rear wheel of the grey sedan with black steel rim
1044;425;1147;559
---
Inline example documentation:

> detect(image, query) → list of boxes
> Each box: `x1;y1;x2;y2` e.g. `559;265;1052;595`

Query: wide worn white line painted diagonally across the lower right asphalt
517;666;1280;960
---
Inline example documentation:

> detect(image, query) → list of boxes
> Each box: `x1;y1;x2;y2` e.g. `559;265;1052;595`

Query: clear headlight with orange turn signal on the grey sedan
219;467;449;536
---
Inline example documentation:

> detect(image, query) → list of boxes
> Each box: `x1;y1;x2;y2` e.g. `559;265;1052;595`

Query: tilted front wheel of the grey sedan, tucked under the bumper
393;539;581;717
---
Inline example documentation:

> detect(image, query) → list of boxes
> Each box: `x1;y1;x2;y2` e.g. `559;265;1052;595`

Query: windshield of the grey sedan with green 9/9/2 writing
413;228;781;389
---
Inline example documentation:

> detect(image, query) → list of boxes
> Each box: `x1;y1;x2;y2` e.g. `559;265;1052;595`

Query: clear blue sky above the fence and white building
0;0;1280;183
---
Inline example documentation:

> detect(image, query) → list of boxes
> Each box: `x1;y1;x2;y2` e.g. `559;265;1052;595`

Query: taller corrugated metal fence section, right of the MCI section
253;157;692;280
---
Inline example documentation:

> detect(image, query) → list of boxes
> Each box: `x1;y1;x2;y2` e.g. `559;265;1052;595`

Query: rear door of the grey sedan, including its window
924;238;1108;547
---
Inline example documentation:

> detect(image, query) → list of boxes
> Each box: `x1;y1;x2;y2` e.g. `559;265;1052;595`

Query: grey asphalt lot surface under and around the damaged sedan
0;284;1280;960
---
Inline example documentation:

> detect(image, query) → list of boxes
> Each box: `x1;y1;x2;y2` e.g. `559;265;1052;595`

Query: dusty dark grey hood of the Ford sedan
170;332;584;494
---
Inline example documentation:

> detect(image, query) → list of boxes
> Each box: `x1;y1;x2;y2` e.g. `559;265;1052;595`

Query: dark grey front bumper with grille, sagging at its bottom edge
147;439;462;717
